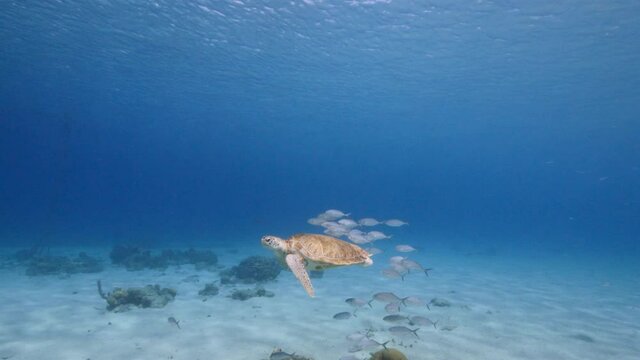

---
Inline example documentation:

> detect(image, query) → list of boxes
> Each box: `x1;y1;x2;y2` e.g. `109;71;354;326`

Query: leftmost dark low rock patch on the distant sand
26;252;103;276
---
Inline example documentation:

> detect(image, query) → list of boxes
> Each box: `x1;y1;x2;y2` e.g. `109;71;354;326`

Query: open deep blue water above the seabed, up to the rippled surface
0;0;640;250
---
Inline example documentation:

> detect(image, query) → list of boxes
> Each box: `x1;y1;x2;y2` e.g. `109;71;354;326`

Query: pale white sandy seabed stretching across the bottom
0;247;640;360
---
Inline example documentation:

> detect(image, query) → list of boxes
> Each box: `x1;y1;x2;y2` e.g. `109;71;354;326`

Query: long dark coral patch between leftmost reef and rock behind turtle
109;245;218;271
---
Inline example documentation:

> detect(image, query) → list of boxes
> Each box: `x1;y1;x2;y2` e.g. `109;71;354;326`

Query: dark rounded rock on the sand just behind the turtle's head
220;256;282;284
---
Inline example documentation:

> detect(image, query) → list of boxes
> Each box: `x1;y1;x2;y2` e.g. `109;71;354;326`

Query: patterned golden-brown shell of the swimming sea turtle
289;234;369;266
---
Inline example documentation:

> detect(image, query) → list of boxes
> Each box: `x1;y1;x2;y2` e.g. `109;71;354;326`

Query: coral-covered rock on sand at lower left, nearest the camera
106;285;176;312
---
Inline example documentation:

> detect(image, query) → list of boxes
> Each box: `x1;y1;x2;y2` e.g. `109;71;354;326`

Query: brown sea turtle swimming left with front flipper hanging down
262;234;373;297
